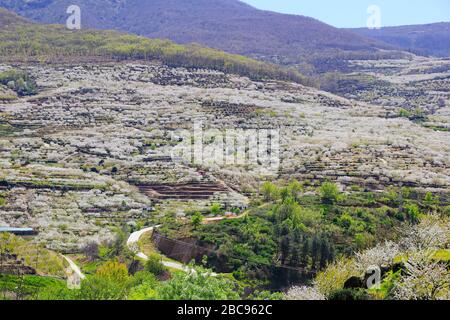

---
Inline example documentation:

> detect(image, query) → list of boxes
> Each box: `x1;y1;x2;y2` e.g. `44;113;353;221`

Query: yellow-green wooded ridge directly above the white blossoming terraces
0;9;307;83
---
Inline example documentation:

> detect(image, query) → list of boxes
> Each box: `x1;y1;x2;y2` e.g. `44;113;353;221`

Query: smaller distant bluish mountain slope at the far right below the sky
349;22;450;57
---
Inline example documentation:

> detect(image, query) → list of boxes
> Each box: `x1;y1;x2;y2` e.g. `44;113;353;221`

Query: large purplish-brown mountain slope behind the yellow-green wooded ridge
0;0;389;59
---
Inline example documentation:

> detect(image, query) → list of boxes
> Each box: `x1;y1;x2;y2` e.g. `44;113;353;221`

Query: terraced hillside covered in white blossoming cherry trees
0;60;450;251
